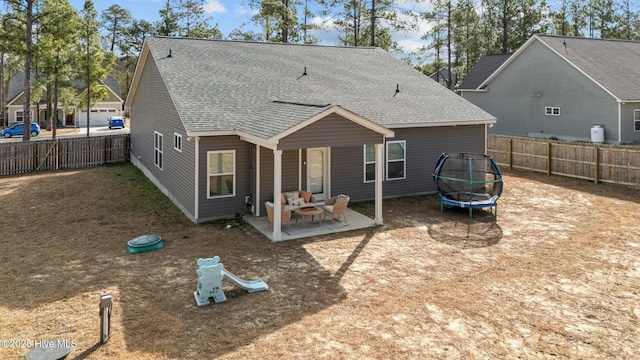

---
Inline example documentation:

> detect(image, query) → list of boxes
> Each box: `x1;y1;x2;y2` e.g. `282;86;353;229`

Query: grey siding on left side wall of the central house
130;56;196;220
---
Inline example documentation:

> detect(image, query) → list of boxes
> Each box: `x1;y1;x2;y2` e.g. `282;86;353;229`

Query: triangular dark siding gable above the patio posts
278;114;382;150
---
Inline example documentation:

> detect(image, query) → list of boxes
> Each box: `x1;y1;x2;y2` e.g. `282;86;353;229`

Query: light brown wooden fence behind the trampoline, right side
487;135;640;186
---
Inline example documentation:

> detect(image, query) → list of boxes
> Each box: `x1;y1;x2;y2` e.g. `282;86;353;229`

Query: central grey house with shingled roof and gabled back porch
125;37;495;240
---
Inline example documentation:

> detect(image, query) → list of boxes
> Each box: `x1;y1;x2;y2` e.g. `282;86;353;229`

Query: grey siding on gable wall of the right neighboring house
464;41;618;142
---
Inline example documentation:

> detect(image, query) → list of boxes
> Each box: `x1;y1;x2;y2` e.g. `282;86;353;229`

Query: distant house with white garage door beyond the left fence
7;72;124;127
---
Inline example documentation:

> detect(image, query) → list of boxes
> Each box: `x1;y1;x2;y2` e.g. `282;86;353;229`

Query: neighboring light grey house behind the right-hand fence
458;35;640;144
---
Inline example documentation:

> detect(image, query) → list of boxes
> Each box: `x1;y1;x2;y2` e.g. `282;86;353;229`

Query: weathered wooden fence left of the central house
0;134;130;175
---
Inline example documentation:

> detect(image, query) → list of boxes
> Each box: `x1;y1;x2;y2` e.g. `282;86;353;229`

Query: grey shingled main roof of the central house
127;37;495;137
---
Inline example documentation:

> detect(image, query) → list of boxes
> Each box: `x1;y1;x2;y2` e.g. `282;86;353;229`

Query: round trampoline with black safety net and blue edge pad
433;153;503;218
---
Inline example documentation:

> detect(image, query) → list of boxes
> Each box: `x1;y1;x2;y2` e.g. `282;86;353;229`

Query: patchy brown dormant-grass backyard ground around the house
0;164;640;359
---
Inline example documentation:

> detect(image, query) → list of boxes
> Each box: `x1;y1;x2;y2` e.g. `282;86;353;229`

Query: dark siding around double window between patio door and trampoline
331;125;485;200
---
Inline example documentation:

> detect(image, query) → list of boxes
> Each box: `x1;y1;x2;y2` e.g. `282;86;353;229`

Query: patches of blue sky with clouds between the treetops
69;0;428;59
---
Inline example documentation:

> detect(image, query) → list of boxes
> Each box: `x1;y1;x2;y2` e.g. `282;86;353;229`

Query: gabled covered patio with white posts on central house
240;101;394;241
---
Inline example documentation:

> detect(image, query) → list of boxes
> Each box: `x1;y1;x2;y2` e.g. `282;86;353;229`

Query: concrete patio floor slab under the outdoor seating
244;208;376;241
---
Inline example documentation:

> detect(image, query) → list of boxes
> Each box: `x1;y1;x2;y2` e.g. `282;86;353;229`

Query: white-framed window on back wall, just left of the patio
207;150;236;199
